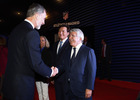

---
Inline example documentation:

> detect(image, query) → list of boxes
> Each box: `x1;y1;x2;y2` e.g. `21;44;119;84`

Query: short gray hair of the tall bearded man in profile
26;3;46;17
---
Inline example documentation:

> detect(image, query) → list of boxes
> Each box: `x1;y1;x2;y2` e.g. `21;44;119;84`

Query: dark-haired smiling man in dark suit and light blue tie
53;25;70;100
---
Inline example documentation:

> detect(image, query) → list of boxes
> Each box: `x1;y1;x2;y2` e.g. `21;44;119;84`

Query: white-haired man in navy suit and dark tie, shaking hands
64;28;96;100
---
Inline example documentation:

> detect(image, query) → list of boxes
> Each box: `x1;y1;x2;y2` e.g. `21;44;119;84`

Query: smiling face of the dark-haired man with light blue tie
58;27;69;40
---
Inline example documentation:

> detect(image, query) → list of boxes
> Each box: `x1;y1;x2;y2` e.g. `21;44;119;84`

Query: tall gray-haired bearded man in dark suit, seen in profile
2;3;57;100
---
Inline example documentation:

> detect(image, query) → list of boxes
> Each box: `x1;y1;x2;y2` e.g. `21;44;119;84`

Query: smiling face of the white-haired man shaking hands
69;32;82;47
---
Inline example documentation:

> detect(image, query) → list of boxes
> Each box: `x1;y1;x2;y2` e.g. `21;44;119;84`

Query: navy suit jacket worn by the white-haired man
64;45;96;98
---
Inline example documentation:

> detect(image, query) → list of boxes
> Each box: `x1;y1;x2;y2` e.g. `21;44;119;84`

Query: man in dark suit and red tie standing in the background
99;39;112;81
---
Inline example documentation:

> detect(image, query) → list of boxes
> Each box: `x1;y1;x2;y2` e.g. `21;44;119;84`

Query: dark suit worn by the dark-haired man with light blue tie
53;39;70;100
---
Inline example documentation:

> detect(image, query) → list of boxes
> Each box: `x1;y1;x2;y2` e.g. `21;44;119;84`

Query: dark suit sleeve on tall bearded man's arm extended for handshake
25;30;52;77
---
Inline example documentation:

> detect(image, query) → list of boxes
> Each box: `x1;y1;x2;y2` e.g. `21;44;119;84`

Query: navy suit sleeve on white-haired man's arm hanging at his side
87;49;97;90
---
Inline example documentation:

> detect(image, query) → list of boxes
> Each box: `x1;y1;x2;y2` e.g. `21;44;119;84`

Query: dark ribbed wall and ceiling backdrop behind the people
0;0;140;83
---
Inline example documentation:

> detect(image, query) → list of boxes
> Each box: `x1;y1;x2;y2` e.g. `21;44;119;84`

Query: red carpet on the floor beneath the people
34;79;140;100
